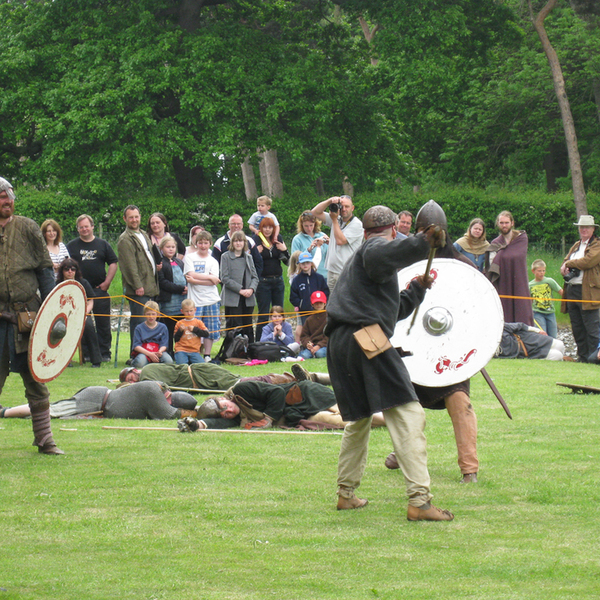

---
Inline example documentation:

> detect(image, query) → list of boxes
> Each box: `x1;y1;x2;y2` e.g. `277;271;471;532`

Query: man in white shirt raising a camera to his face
310;196;363;292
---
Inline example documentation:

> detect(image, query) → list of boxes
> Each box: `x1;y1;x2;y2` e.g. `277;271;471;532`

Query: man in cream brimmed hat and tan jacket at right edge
560;215;600;362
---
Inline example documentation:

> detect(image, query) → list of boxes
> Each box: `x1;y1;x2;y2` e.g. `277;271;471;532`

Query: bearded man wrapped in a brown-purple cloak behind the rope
486;210;533;325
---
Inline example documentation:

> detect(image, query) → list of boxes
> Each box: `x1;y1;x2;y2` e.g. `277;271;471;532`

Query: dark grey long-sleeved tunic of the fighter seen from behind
325;234;429;421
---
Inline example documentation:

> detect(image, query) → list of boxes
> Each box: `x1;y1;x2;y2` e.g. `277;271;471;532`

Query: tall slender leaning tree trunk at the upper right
528;0;587;216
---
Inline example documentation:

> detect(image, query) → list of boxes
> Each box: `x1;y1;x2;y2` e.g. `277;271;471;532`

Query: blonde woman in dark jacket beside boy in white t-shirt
158;235;187;356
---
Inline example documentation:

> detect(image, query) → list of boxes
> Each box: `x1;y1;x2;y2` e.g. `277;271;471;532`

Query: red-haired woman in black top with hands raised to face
252;217;290;340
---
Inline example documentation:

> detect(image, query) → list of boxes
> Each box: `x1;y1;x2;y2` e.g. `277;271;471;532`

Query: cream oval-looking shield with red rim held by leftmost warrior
28;281;87;383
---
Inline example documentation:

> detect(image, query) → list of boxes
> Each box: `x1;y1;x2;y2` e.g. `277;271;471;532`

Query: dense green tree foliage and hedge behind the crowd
0;0;600;215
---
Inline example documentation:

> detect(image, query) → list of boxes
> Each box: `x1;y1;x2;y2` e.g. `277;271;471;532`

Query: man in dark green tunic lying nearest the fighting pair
177;381;384;433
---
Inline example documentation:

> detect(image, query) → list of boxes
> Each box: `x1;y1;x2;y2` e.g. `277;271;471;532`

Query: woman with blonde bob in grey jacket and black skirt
221;231;258;343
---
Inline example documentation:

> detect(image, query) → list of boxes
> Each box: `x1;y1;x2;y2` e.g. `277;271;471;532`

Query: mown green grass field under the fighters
0;339;600;600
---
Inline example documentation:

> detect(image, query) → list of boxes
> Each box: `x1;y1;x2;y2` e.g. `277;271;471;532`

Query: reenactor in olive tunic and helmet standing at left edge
0;177;64;454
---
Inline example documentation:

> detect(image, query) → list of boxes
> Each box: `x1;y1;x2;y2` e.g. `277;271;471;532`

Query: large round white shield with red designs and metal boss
390;258;504;387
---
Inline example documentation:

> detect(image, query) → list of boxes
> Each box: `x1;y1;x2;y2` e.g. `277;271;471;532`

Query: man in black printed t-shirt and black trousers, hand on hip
67;215;118;362
